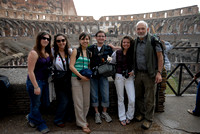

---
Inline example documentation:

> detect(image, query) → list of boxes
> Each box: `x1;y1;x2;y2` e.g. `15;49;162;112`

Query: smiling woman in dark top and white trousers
111;36;135;126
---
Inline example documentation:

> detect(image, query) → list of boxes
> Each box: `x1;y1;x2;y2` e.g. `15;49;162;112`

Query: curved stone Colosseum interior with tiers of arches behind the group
0;0;200;113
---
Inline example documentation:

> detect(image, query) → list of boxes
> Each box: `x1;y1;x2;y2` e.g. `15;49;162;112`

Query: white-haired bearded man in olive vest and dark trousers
133;21;163;129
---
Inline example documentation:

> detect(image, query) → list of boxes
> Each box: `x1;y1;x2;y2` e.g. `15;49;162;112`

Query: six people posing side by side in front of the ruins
26;21;194;133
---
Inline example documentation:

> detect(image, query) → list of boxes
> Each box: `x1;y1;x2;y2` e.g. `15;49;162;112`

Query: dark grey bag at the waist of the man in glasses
97;63;116;77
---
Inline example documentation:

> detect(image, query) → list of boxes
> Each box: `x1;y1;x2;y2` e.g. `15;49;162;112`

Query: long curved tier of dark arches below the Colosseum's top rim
0;14;200;37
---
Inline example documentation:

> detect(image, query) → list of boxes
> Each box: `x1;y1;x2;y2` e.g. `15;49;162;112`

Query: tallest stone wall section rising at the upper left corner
0;0;77;15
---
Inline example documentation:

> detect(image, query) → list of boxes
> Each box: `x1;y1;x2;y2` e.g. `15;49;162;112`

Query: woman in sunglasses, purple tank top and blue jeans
26;32;53;133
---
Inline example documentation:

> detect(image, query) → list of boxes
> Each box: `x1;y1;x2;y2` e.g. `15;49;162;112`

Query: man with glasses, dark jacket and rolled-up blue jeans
88;30;113;124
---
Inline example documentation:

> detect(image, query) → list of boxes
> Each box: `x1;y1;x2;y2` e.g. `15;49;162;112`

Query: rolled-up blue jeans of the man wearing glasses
90;76;109;107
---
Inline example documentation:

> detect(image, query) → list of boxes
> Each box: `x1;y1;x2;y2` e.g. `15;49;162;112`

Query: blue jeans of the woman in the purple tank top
26;79;50;131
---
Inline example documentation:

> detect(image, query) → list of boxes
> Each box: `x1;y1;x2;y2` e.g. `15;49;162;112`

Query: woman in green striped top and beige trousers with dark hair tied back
70;33;90;133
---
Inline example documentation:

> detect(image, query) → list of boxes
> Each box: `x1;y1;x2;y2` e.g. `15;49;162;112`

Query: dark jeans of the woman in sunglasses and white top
54;90;69;124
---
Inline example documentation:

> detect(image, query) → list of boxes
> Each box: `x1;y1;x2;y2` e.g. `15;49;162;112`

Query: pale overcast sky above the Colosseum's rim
74;0;200;19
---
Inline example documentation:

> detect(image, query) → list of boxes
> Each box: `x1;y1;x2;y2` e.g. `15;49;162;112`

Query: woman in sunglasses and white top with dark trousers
52;33;73;127
